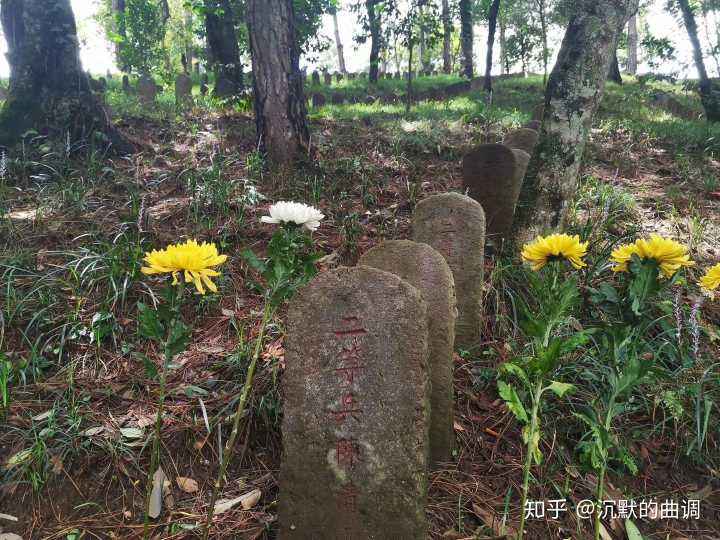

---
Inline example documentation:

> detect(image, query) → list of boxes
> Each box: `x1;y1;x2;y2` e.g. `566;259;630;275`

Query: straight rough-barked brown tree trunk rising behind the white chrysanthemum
247;0;310;165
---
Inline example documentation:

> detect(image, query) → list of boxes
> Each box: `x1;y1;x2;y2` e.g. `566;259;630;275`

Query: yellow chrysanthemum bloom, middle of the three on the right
610;234;695;278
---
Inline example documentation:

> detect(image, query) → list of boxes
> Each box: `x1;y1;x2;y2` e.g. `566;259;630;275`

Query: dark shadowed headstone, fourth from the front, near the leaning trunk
462;144;520;243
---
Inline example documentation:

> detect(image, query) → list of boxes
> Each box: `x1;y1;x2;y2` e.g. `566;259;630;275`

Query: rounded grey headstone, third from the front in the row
412;193;485;348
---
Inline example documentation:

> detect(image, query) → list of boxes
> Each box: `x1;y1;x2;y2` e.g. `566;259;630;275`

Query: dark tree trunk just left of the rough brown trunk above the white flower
205;0;243;98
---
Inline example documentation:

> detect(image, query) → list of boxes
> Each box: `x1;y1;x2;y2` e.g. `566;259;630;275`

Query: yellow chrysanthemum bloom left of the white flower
140;240;227;294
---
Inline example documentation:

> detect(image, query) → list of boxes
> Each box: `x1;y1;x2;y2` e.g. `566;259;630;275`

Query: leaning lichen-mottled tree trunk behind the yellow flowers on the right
514;0;638;243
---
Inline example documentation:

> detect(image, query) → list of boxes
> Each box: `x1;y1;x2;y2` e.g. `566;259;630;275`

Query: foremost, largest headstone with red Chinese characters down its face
278;266;429;540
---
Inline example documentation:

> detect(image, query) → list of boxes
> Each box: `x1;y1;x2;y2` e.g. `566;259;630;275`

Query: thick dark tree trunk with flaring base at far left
0;0;134;153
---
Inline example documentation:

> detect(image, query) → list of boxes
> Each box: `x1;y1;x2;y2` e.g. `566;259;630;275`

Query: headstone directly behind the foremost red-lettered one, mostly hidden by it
358;240;457;466
